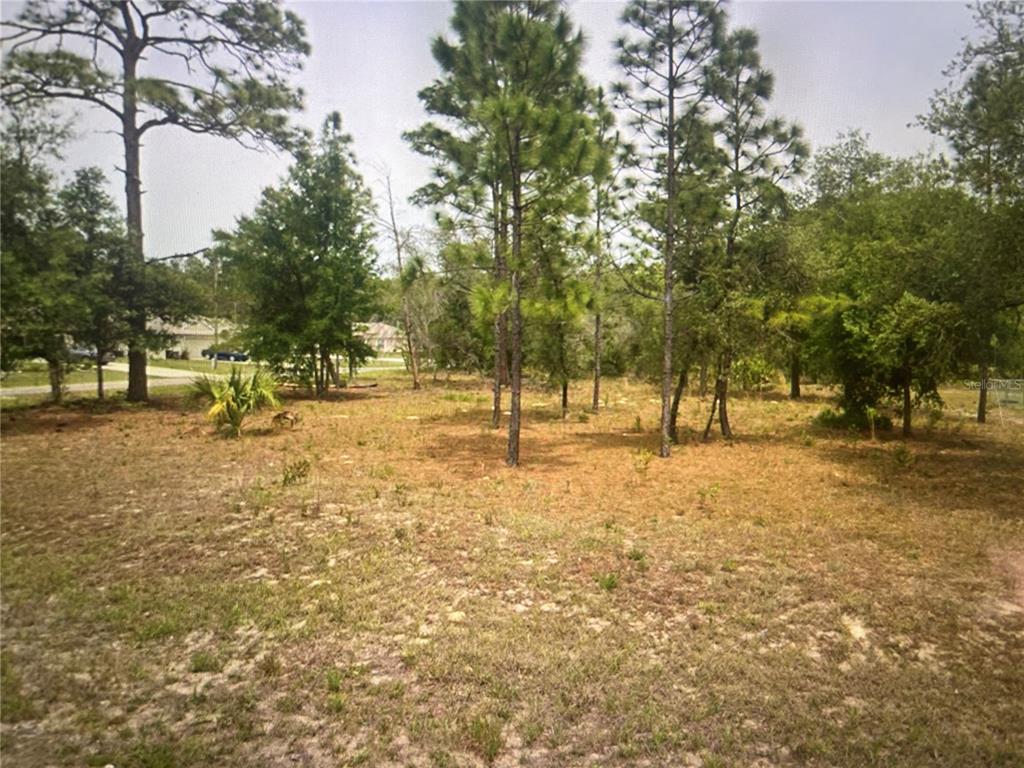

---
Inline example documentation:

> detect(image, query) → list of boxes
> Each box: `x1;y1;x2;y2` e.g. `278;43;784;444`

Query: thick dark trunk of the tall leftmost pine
121;49;150;402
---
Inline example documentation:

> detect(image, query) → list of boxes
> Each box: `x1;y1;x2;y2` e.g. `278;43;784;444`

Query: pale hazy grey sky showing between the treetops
3;0;972;263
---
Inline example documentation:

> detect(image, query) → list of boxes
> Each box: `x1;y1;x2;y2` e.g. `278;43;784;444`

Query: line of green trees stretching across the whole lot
4;0;1024;465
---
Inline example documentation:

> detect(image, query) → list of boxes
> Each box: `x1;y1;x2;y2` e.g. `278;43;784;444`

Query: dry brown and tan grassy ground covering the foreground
0;376;1024;768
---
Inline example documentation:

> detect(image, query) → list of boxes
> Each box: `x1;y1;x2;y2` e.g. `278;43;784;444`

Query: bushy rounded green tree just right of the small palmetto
218;113;377;394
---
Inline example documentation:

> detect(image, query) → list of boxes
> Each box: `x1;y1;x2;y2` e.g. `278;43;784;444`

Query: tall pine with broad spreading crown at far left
2;0;309;400
